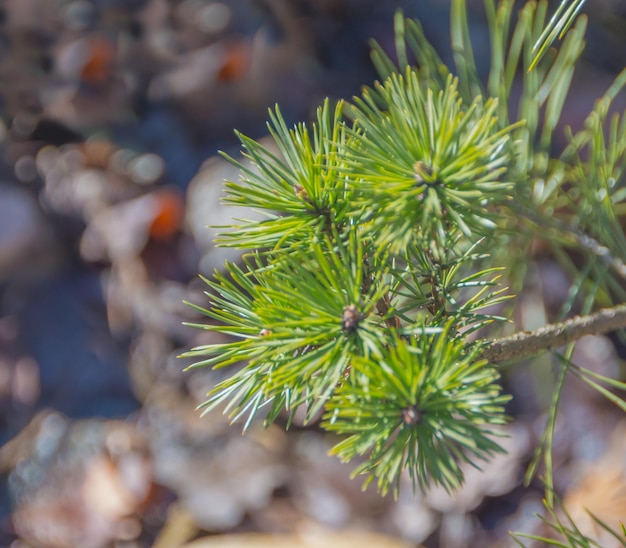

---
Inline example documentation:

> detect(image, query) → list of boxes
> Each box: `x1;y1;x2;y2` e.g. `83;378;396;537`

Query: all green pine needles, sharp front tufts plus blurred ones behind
185;0;626;540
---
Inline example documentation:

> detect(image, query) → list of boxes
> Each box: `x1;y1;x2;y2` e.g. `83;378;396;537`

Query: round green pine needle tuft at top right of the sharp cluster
347;68;513;252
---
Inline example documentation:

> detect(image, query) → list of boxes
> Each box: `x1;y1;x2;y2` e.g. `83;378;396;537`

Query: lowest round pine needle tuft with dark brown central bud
323;325;509;496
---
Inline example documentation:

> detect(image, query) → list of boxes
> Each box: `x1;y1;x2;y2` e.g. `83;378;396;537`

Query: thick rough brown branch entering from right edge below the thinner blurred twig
479;304;626;362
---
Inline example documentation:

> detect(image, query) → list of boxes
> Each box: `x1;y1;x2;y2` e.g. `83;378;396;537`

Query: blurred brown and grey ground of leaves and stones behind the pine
0;0;626;548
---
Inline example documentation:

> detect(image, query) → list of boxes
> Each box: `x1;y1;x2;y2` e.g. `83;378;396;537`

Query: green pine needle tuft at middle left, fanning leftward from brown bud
185;230;392;426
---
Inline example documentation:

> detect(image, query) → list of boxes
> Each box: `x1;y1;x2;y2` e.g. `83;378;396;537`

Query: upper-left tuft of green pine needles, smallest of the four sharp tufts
217;100;351;250
